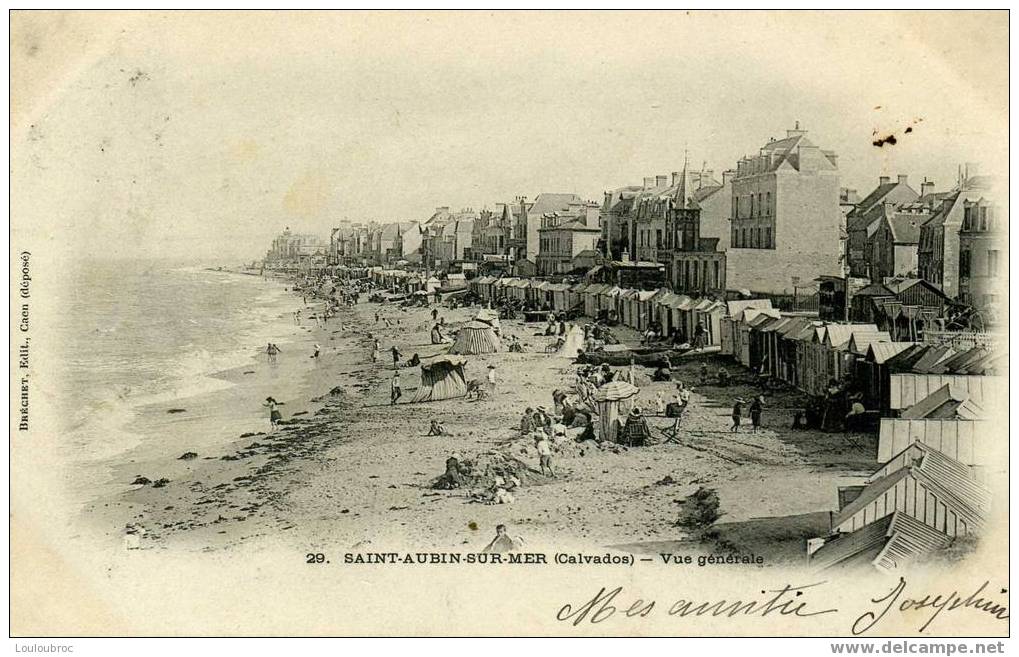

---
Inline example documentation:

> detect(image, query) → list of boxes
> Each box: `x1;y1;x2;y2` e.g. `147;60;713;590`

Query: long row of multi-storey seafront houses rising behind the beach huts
303;122;1007;334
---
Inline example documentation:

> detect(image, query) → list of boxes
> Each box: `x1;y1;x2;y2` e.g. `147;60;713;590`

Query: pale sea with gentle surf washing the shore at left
56;260;302;501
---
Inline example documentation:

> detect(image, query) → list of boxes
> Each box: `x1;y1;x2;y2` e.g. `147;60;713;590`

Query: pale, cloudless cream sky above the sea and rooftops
11;11;1008;264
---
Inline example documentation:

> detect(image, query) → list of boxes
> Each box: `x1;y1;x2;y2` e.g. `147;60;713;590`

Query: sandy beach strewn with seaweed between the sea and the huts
84;285;876;564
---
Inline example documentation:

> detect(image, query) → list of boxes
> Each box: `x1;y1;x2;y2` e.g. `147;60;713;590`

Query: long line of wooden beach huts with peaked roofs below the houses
470;277;1007;571
